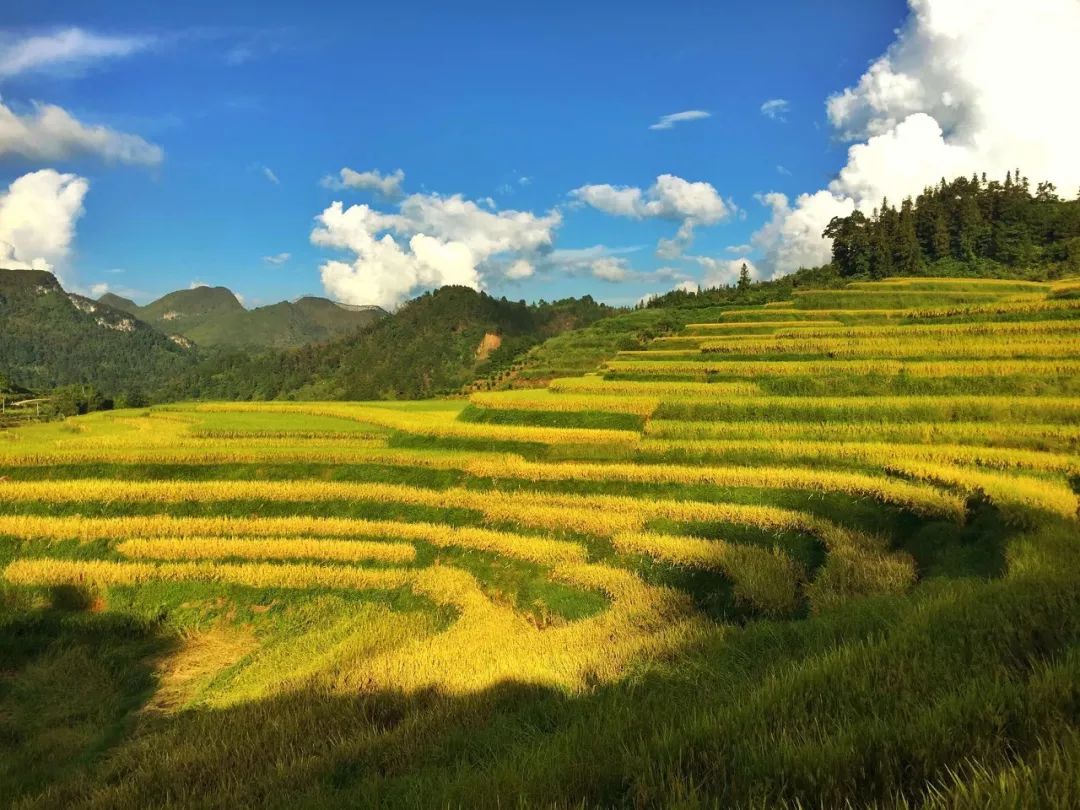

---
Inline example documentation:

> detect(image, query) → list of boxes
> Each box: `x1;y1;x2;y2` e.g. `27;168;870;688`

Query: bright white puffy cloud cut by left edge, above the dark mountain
0;168;90;270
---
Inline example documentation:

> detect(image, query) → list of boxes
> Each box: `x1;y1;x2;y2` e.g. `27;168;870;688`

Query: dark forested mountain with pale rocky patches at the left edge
0;269;197;397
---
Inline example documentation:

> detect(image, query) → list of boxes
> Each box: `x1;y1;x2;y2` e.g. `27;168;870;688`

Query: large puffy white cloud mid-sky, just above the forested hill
311;194;562;308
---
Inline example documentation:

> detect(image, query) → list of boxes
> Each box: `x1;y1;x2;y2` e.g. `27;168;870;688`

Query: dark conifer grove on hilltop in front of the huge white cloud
823;170;1080;279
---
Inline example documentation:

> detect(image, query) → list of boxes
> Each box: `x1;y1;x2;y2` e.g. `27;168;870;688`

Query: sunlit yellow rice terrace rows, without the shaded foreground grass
0;279;1080;702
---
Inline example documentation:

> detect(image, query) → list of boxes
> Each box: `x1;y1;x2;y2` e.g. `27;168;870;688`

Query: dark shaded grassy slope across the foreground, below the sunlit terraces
0;546;1080;808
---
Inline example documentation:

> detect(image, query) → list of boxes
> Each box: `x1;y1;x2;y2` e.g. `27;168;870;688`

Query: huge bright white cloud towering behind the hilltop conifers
754;0;1080;274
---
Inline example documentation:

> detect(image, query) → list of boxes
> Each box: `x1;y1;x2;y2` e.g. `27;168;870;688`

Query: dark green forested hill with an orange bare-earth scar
177;286;615;400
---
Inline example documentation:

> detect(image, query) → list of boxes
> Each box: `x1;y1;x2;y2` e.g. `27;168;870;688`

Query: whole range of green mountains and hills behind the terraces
0;269;615;403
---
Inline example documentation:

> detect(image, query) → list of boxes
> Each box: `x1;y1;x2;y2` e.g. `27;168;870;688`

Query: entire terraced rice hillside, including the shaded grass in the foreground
0;279;1080;807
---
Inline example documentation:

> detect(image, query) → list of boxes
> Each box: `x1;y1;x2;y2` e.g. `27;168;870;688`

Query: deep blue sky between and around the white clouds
0;0;920;305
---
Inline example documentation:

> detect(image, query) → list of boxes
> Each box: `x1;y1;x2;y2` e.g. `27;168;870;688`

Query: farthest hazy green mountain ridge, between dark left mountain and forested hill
98;286;387;350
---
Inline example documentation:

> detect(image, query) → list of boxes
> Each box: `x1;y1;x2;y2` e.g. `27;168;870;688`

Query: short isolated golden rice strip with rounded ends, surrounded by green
116;537;416;564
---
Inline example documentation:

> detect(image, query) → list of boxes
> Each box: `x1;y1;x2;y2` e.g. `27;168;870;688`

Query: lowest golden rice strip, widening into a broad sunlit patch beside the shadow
4;559;704;694
